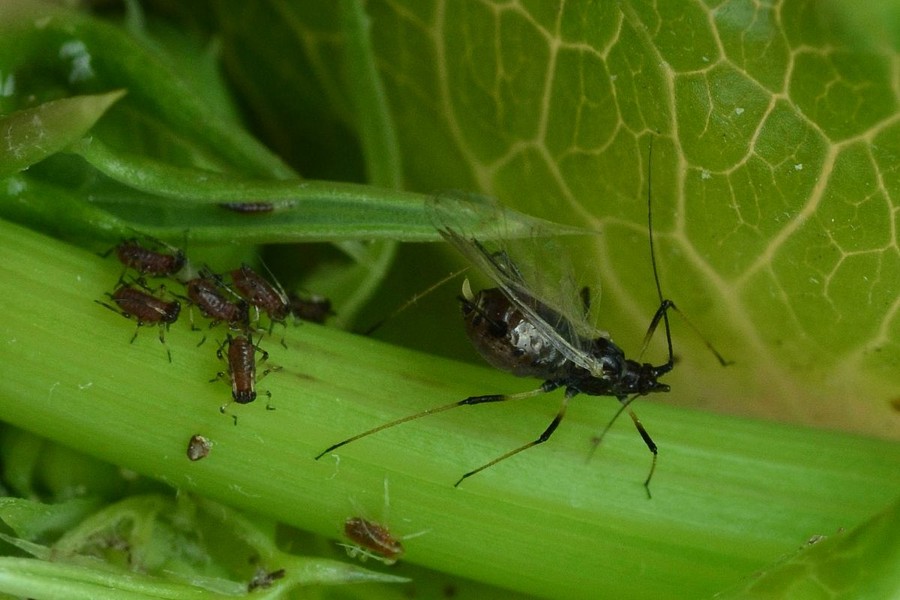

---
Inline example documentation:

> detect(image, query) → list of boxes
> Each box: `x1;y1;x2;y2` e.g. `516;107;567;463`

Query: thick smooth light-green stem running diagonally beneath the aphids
0;217;900;598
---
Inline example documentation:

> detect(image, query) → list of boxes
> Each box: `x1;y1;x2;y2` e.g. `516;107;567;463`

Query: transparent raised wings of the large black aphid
429;193;608;374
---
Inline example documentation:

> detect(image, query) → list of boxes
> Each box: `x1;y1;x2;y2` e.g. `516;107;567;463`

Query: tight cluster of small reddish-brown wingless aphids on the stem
97;239;331;412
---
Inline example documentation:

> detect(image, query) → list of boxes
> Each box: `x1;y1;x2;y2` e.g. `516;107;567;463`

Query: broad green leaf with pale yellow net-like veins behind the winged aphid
342;0;900;439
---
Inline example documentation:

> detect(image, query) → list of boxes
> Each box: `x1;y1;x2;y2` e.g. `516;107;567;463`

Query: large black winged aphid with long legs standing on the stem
316;156;727;497
